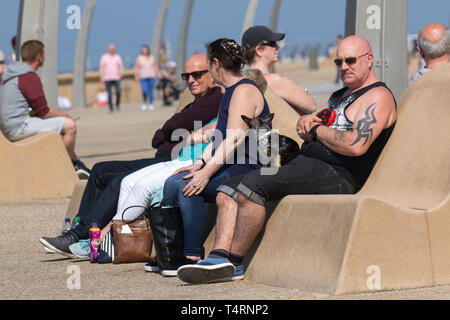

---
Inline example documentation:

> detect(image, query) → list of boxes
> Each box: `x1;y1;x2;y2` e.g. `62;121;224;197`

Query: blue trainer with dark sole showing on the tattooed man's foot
177;257;236;284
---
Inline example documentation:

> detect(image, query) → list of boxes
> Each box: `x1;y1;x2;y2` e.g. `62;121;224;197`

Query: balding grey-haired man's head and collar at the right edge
413;23;450;81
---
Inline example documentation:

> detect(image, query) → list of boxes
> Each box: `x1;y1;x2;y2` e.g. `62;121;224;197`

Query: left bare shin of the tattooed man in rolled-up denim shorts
213;192;238;251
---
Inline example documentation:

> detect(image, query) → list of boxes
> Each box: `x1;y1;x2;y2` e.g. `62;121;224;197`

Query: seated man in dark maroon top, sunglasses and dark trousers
40;54;222;257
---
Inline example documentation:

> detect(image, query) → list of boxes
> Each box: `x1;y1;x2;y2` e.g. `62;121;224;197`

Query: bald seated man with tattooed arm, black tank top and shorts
178;36;397;283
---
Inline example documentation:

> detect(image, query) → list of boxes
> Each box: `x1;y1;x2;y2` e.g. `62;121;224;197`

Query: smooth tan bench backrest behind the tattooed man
360;64;450;209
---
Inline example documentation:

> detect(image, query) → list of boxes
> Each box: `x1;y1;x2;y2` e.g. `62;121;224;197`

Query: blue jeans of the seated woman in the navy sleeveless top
163;170;231;257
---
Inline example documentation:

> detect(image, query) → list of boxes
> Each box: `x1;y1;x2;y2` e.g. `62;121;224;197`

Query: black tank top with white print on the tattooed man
301;82;397;191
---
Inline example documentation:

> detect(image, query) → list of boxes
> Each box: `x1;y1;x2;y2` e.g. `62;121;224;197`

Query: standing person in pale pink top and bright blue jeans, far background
134;44;161;110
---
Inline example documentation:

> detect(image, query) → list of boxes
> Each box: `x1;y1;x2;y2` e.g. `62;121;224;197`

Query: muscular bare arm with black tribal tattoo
316;90;397;156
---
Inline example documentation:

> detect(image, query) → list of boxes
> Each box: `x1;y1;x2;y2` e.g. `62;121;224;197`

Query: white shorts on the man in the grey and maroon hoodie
8;117;66;141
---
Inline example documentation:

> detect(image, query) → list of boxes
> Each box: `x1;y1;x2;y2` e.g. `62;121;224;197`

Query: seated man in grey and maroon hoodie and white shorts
0;40;90;178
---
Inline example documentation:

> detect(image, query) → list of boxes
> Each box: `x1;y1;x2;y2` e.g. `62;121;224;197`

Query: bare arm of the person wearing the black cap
265;74;316;114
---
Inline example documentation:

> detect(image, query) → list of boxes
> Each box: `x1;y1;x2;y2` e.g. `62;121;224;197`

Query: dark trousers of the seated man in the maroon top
74;152;171;239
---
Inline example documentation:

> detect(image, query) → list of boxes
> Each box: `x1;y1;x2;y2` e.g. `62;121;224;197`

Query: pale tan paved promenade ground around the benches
0;65;450;300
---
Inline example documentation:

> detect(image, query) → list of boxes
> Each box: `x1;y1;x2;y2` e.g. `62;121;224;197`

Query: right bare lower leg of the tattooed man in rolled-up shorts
230;193;266;257
